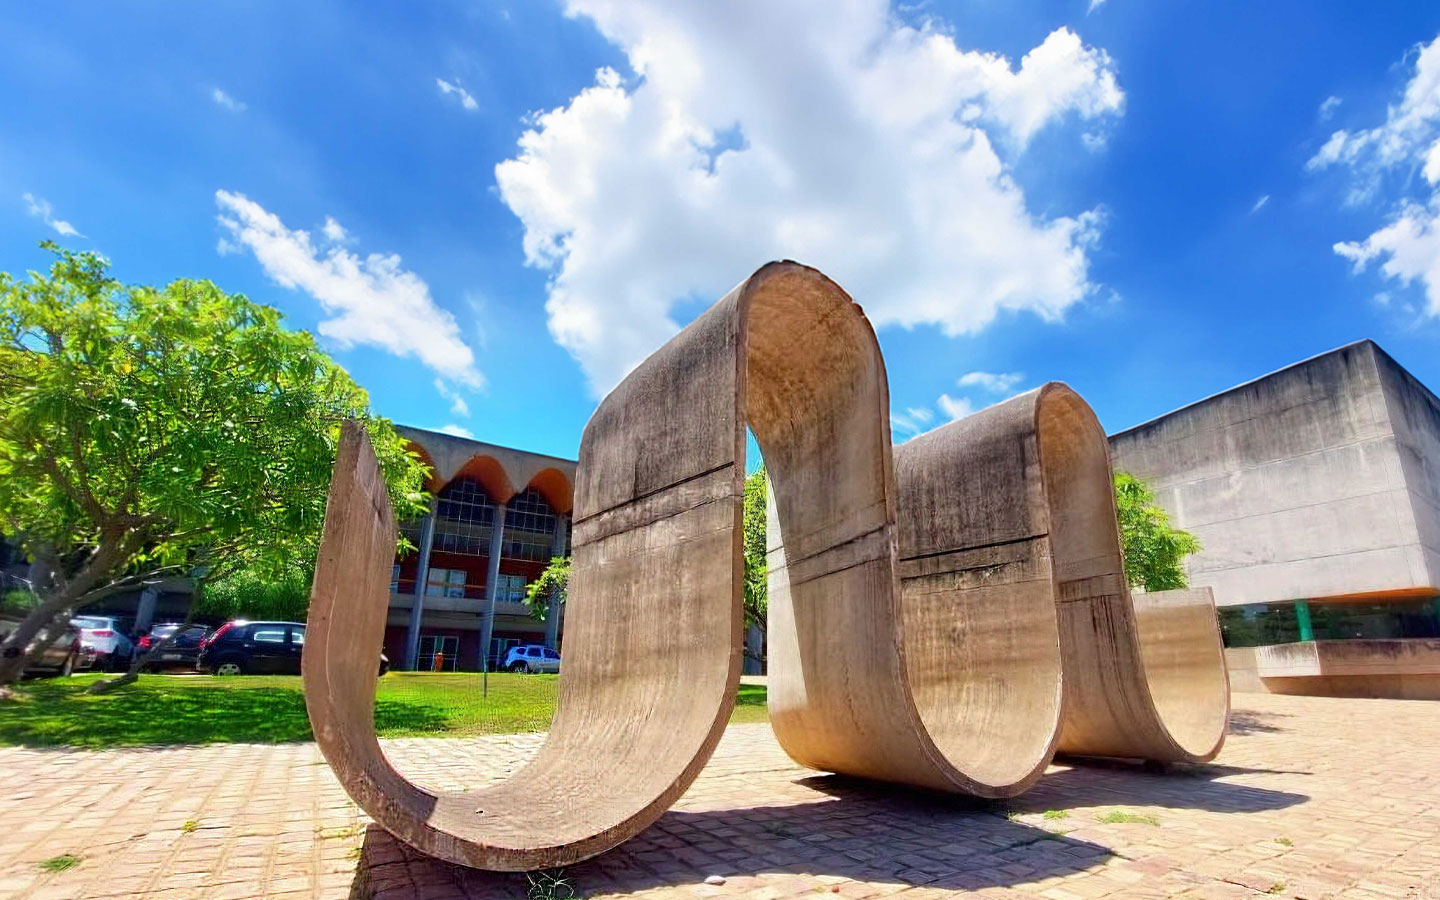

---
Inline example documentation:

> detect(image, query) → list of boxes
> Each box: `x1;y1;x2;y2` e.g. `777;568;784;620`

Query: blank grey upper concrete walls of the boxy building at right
1110;341;1440;606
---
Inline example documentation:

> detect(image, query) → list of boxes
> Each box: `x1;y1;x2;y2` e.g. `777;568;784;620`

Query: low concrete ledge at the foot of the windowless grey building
1225;638;1440;700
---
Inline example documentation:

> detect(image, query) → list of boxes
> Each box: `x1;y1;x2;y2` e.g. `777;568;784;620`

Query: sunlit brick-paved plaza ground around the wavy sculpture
0;694;1440;900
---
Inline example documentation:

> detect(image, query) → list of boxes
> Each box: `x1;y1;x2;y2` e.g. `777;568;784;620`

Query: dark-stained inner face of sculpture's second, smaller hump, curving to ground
894;385;1061;796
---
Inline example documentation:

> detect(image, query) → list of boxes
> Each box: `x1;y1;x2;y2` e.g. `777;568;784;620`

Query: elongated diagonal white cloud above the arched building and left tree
215;190;484;387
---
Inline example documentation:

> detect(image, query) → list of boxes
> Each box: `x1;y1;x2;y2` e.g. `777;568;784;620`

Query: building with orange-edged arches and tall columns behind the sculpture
384;425;576;671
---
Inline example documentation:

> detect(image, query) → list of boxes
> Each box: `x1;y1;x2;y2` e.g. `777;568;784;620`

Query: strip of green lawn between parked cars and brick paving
0;672;766;747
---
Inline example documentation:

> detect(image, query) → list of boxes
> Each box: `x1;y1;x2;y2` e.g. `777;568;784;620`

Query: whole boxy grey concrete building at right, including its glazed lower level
1110;340;1440;698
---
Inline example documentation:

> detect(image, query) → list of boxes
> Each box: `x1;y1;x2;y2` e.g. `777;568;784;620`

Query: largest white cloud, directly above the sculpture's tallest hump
495;0;1125;393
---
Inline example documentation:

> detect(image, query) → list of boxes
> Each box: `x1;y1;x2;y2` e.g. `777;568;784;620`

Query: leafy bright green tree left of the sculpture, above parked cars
0;242;425;685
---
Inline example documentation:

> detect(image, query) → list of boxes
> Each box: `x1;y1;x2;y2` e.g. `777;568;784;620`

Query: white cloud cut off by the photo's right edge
1306;37;1440;317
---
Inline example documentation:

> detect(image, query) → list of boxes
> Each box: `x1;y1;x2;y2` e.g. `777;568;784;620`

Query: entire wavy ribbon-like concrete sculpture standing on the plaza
304;262;1224;870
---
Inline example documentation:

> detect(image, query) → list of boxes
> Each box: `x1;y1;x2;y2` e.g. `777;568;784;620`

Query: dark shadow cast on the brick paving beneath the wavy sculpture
351;776;1110;900
